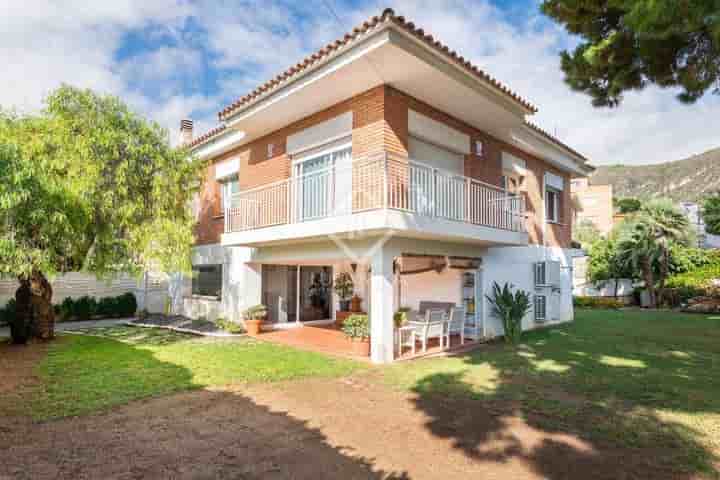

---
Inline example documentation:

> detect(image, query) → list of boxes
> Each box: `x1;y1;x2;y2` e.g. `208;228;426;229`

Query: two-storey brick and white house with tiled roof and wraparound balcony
173;9;592;363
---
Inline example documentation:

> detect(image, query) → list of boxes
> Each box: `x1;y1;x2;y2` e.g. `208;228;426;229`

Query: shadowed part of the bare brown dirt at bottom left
0;360;409;480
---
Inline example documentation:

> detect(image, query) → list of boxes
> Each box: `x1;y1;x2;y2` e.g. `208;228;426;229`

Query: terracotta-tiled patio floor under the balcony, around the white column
257;325;480;361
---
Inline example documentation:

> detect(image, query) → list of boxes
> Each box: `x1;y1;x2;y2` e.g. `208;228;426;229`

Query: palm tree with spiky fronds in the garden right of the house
618;199;691;307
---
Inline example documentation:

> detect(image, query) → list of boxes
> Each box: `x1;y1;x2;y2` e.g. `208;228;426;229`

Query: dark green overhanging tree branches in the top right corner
541;0;720;107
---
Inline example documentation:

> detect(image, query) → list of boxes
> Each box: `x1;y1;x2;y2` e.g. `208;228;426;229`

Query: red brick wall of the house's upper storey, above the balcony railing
196;86;571;248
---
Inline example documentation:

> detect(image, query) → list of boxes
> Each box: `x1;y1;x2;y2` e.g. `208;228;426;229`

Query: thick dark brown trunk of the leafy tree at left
11;272;55;343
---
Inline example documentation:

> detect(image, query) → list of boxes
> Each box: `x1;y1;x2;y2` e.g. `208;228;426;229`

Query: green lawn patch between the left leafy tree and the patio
27;326;363;420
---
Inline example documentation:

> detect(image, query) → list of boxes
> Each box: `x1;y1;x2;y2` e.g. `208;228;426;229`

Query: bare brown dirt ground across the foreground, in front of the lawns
0;362;691;480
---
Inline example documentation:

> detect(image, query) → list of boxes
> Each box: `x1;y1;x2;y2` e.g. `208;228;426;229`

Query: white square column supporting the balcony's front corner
370;248;394;363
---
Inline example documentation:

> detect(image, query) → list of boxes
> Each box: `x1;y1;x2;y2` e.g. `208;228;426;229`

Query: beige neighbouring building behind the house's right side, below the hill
570;178;614;235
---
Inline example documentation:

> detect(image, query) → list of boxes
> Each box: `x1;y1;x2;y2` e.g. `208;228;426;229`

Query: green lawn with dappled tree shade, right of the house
386;310;720;475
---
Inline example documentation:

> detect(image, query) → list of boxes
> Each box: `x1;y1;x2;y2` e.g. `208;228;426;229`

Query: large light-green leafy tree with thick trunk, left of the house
0;86;202;342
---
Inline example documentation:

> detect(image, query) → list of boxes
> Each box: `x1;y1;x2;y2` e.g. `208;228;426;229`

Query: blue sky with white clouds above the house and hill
0;0;720;164
